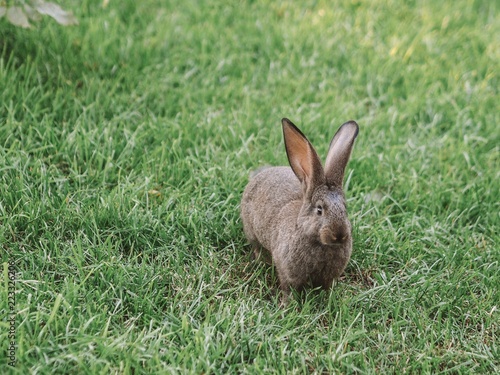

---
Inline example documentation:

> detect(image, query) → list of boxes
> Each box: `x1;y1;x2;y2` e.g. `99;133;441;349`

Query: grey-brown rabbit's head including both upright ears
282;118;358;247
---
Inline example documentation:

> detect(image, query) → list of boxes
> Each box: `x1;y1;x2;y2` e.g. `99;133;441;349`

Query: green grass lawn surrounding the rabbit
0;0;500;374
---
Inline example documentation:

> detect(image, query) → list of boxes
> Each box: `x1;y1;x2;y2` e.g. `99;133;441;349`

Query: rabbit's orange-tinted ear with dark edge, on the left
281;118;326;197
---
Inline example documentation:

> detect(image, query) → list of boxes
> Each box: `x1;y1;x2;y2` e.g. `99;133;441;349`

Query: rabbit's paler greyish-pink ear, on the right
325;121;359;187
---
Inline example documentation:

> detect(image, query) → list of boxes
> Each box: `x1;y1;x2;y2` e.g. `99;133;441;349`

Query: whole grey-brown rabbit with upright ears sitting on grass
240;118;359;304
